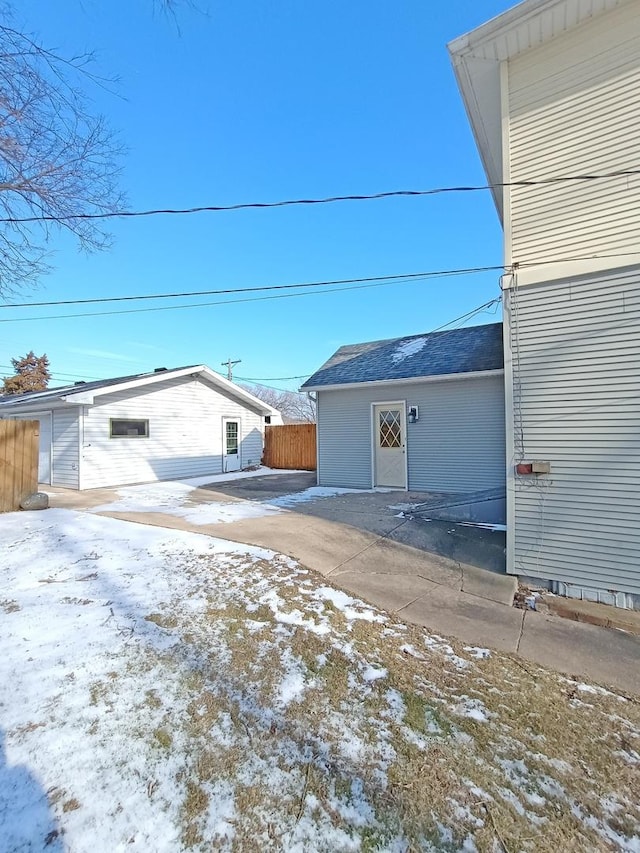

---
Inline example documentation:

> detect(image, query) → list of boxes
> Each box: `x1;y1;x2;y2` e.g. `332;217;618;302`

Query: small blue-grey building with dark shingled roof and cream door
302;323;506;493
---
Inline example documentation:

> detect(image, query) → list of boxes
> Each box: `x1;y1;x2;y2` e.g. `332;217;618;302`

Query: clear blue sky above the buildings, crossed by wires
0;0;512;388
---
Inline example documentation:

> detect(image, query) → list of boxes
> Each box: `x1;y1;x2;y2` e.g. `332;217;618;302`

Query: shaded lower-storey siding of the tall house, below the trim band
508;268;640;594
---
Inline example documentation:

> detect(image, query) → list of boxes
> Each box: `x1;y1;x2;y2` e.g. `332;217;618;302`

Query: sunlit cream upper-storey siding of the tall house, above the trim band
505;3;640;266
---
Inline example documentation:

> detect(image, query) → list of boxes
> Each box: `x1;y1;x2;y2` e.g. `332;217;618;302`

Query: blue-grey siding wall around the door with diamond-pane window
318;375;505;492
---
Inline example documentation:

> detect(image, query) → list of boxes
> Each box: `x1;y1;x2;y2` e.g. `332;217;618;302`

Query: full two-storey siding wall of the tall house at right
502;2;640;606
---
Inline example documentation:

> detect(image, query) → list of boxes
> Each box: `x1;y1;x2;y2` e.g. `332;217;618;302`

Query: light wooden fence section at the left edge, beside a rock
0;420;40;512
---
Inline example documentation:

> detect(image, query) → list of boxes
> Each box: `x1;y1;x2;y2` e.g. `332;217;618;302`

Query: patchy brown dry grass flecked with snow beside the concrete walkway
62;548;640;853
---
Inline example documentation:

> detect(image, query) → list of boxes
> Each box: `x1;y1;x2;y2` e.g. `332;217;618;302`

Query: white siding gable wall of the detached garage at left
81;379;264;489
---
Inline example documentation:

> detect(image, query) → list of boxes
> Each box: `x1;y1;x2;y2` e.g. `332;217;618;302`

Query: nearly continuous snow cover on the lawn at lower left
0;509;272;851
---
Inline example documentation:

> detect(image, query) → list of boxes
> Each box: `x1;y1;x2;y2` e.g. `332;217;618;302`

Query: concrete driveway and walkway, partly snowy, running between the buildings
47;473;640;693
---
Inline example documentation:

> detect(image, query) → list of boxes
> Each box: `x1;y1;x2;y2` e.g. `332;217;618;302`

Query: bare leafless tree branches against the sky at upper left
0;5;124;295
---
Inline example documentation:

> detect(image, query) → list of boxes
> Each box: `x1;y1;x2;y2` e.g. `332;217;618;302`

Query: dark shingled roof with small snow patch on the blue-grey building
302;323;504;388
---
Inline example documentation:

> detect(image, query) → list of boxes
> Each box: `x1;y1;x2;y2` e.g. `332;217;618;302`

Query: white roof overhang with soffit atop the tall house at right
448;0;634;221
